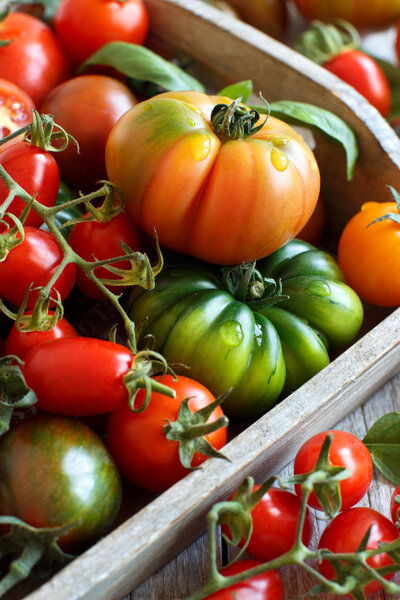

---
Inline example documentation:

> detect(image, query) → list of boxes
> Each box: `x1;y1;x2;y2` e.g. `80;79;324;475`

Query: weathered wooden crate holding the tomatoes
18;0;400;600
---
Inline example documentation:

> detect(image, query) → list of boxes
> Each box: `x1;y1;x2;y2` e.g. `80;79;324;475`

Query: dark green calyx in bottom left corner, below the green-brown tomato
0;516;75;596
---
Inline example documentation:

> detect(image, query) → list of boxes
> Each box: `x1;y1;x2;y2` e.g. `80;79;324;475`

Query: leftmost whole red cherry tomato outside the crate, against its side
223;485;313;562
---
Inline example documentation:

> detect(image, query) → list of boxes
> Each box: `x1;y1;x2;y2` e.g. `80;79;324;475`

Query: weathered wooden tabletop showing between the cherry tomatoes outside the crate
123;375;400;600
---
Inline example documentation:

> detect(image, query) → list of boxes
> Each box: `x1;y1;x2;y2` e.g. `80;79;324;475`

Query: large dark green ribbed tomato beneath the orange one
128;240;363;417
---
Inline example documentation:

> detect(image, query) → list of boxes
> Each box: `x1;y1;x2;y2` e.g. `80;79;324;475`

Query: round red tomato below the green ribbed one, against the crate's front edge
107;375;226;491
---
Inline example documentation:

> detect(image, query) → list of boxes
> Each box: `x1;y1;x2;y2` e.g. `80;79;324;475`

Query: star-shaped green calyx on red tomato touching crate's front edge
163;390;230;471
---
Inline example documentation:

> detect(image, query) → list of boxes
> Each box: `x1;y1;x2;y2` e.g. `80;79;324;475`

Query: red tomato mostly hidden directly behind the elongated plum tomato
6;311;78;358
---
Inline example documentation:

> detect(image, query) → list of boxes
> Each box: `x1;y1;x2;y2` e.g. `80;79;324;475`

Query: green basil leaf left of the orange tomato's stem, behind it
78;42;204;92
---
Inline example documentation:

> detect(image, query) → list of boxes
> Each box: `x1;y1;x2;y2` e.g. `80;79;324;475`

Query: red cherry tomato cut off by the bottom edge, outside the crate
206;560;285;600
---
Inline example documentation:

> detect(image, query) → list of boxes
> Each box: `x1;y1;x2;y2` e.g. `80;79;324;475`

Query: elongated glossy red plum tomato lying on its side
22;337;133;416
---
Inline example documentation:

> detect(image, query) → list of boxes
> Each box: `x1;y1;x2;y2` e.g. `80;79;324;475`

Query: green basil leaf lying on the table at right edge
363;412;400;485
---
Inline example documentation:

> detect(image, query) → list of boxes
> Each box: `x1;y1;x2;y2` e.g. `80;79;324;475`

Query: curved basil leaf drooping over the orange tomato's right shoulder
266;100;358;181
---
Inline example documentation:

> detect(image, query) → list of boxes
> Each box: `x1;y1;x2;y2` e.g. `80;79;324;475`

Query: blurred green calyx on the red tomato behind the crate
295;19;361;65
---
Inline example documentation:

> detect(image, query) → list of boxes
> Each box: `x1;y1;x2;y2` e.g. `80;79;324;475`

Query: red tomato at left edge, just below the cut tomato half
0;142;60;229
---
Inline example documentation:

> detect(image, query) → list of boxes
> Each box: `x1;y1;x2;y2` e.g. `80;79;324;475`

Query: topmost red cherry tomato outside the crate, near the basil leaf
294;430;373;510
